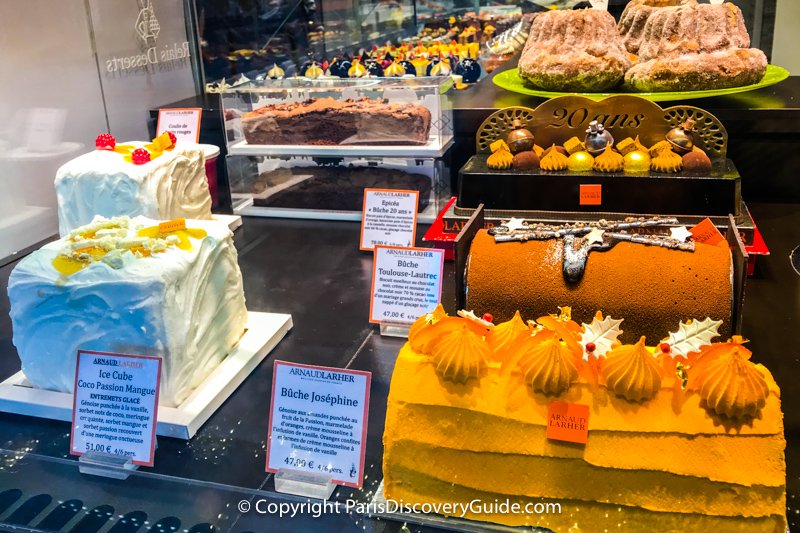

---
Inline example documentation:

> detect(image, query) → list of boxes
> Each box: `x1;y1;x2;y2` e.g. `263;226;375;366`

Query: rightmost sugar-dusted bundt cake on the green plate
625;3;767;91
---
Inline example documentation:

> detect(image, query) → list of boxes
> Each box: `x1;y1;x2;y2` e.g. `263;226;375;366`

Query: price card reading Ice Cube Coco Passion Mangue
70;350;161;466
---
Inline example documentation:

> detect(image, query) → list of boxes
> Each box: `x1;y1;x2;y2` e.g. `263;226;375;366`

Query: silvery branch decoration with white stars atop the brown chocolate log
489;217;695;283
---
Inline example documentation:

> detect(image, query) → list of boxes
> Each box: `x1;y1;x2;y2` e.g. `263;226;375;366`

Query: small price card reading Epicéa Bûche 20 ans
360;189;419;250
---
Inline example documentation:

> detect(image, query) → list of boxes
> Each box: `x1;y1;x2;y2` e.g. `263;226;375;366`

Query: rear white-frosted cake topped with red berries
55;133;211;236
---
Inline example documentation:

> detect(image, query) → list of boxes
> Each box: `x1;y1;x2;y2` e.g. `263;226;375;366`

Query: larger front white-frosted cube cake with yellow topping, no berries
8;217;247;406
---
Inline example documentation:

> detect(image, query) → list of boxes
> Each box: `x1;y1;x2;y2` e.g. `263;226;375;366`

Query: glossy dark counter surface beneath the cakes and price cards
0;204;800;533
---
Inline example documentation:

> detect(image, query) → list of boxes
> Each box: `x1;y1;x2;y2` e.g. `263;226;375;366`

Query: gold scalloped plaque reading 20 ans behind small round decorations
476;95;728;159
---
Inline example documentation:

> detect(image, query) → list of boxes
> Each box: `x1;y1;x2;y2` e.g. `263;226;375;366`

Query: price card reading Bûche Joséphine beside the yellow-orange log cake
267;361;372;488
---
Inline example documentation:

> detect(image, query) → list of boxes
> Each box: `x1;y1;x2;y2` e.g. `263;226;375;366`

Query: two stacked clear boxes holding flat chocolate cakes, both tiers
221;74;453;221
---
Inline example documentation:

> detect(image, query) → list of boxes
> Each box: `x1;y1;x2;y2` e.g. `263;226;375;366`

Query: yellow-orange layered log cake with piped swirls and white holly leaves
383;308;786;533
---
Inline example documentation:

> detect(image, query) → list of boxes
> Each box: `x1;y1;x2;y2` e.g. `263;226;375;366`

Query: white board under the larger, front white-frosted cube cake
0;312;292;440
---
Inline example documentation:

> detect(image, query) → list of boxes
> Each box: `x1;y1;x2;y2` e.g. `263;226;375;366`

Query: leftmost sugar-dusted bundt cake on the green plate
519;9;631;92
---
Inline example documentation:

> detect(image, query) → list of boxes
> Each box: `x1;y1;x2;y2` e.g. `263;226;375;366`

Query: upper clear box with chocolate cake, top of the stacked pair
221;76;453;153
